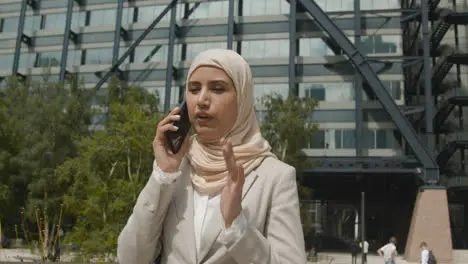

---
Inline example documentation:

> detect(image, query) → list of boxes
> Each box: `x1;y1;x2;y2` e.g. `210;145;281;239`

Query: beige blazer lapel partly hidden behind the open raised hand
197;170;258;263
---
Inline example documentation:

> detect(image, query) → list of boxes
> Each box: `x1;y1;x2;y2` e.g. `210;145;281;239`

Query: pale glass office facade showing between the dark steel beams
0;0;414;153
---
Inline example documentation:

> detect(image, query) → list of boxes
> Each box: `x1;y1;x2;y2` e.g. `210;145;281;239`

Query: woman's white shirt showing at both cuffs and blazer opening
153;162;247;258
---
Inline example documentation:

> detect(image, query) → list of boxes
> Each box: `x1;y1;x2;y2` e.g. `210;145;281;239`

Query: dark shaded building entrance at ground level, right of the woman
304;174;419;253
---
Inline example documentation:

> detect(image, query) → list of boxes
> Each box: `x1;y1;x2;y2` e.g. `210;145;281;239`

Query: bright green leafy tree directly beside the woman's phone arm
56;79;159;259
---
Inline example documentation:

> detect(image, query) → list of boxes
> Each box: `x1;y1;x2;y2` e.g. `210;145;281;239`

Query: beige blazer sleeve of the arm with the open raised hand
228;167;307;264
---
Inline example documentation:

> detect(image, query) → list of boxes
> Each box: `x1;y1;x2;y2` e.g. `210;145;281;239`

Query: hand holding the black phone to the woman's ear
153;107;190;172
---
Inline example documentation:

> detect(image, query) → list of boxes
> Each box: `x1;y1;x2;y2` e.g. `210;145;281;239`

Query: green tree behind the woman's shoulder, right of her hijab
261;94;317;233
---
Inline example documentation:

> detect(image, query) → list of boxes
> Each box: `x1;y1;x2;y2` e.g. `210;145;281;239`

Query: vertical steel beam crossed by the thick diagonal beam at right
354;0;364;156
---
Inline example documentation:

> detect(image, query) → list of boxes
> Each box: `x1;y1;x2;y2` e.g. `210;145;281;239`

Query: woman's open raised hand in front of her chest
221;140;245;228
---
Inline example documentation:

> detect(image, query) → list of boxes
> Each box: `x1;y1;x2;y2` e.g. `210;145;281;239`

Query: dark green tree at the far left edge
0;76;90;253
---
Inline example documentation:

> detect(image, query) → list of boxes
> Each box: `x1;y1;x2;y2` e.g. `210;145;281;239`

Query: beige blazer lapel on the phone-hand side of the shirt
175;166;196;259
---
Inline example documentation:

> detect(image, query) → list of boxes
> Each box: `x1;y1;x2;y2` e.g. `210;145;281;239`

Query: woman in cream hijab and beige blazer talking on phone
117;49;306;264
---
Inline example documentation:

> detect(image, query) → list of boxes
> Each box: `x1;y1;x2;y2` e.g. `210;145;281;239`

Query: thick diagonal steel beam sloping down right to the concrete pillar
299;0;439;183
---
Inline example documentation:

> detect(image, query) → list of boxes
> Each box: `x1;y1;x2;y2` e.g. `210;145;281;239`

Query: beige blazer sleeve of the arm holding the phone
117;164;180;264
